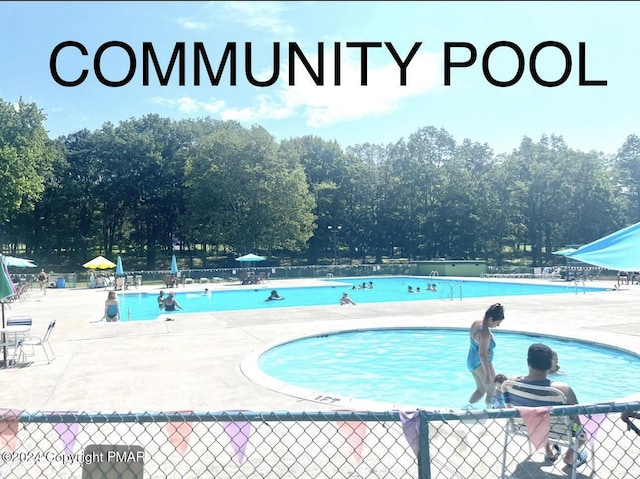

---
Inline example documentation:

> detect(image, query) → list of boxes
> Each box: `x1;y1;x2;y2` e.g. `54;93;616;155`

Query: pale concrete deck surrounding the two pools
0;278;640;412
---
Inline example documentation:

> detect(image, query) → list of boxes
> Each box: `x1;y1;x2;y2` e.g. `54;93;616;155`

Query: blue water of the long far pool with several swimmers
119;276;606;321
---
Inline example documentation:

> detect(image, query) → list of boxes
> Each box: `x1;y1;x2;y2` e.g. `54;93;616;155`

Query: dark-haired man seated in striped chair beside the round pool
510;343;588;466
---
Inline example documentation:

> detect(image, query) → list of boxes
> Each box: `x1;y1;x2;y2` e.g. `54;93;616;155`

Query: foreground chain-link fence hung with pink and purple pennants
0;402;640;479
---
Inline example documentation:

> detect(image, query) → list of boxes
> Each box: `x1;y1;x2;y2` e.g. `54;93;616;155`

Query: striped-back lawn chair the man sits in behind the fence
501;380;595;479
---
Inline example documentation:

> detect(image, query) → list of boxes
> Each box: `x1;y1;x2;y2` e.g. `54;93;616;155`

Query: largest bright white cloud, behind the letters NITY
153;47;441;128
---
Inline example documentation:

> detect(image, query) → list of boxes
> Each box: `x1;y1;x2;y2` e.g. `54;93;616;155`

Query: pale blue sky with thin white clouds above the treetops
0;1;640;153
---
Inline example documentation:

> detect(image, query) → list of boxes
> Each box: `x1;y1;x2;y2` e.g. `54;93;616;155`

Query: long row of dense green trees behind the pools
0;100;640;269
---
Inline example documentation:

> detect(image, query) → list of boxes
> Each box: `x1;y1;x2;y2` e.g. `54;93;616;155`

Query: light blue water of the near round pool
258;329;640;408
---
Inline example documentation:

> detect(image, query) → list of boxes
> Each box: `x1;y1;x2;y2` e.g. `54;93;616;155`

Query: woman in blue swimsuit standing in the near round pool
467;303;504;407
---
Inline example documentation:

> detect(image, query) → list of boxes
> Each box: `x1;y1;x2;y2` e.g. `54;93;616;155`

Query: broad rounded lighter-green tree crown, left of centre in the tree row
185;127;315;253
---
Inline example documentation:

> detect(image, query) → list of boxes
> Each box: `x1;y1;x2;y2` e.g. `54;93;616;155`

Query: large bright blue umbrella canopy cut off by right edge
565;223;640;271
